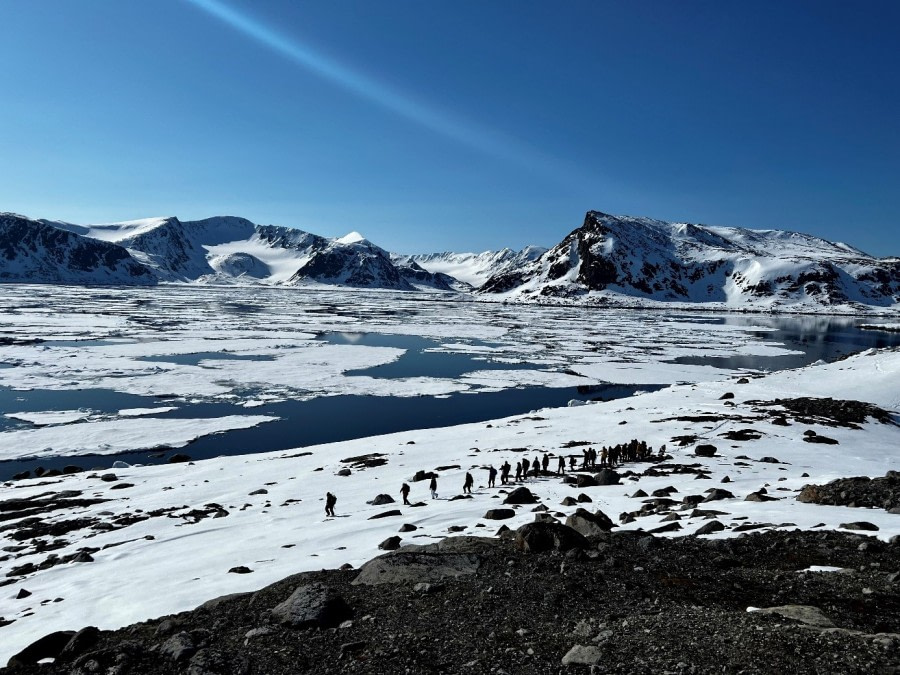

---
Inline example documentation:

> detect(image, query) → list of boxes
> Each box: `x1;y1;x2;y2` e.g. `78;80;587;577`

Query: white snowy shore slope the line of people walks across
0;351;900;662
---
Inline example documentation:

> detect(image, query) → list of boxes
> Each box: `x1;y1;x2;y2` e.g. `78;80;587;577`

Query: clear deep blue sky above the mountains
0;0;900;255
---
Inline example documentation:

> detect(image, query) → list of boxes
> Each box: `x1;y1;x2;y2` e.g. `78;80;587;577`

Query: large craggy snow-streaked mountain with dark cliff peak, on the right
479;211;900;308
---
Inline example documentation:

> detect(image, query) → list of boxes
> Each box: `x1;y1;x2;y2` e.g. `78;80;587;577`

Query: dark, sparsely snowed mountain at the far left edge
0;213;157;285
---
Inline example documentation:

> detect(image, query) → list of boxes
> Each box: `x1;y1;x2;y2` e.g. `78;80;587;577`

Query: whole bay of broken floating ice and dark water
0;285;900;478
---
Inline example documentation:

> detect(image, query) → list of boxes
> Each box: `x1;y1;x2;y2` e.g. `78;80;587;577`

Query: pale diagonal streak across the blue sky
187;0;596;190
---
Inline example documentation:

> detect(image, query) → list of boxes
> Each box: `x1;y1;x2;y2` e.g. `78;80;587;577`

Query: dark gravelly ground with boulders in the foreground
2;524;900;675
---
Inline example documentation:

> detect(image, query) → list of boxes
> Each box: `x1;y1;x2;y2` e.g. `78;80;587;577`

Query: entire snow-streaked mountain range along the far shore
0;211;900;310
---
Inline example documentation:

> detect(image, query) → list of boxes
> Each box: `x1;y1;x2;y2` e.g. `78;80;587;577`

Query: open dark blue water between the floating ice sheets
0;316;900;479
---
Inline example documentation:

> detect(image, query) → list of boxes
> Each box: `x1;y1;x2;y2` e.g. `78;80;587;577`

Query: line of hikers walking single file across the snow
325;439;666;516
